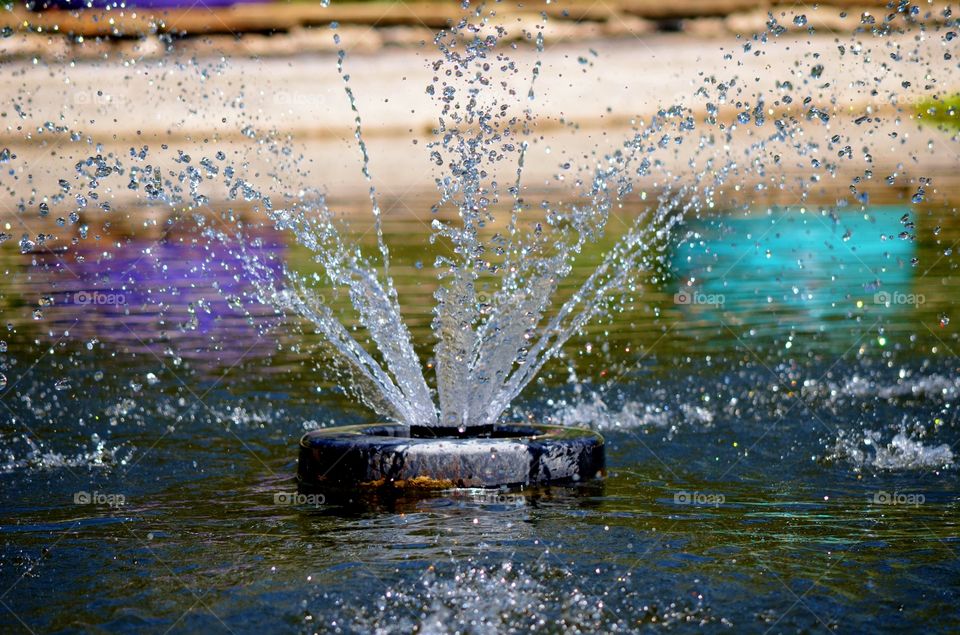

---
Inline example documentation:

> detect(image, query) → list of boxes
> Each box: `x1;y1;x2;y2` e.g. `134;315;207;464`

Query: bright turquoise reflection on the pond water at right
674;207;916;326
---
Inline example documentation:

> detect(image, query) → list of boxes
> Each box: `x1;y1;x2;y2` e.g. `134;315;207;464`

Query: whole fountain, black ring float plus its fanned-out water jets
195;7;952;489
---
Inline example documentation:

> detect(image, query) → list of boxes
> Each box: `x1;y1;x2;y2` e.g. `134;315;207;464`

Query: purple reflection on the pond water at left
9;226;286;370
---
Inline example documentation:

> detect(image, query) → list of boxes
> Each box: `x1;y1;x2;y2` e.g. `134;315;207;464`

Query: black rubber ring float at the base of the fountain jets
297;424;605;489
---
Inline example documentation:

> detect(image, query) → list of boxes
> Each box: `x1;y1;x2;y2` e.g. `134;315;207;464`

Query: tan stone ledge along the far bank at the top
0;0;932;59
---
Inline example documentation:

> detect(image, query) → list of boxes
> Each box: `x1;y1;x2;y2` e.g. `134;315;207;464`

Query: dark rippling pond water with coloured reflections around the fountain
0;197;960;633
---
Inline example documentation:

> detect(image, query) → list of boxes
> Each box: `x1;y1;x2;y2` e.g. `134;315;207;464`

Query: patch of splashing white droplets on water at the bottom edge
305;550;733;635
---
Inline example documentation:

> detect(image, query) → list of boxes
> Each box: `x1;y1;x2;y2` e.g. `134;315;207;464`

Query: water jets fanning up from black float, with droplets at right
202;8;952;427
